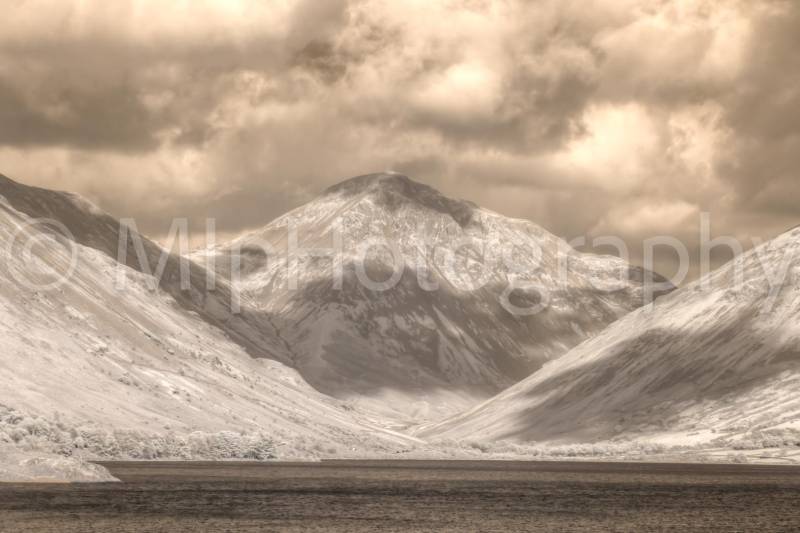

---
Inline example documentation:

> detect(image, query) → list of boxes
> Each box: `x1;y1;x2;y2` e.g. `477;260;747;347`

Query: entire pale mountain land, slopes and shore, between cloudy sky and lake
0;173;800;479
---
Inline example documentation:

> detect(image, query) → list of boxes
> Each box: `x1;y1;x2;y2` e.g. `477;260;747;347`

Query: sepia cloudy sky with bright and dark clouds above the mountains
0;0;800;275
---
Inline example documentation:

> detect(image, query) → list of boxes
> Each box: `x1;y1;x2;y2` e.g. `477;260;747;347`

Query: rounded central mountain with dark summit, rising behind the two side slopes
193;173;668;420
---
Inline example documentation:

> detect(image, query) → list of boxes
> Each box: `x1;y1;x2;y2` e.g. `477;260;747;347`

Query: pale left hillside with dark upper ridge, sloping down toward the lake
0;176;416;454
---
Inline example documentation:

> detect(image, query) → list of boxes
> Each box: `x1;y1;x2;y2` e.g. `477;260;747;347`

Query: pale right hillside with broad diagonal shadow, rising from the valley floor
419;228;800;444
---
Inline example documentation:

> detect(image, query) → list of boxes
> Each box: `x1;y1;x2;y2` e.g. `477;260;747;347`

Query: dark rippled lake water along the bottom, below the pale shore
0;461;800;533
